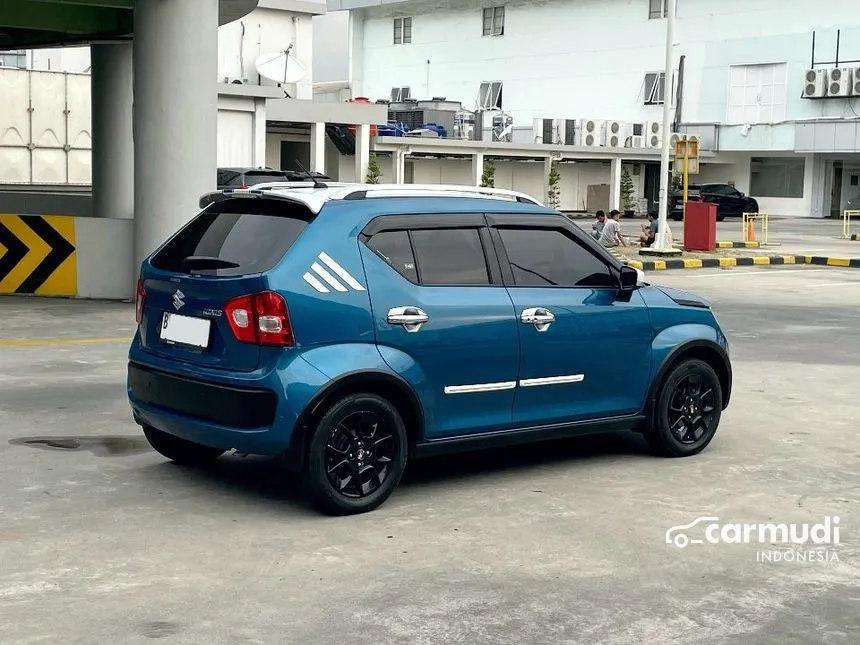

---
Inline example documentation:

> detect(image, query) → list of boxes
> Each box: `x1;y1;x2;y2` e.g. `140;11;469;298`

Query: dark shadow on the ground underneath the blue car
139;432;650;512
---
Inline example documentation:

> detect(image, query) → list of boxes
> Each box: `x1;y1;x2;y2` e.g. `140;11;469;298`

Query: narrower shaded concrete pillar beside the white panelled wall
90;43;134;219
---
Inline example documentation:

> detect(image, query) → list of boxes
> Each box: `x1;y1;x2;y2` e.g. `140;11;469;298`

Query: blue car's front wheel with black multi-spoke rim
645;359;723;457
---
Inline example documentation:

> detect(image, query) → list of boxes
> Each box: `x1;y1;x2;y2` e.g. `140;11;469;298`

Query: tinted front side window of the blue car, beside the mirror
499;228;615;287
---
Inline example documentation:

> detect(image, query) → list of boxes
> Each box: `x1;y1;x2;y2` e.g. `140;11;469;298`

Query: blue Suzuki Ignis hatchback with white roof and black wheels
128;184;732;514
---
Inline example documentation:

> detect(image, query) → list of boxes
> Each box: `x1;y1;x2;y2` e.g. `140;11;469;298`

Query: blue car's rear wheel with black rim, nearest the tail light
303;394;408;515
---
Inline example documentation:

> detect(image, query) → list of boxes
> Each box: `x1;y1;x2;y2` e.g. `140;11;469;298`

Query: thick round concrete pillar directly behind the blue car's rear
134;0;218;275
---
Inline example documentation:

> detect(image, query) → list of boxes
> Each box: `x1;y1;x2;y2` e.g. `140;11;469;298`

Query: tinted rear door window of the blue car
411;228;490;285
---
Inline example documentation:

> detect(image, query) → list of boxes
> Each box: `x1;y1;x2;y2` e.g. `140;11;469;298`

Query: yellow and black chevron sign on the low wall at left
0;215;78;296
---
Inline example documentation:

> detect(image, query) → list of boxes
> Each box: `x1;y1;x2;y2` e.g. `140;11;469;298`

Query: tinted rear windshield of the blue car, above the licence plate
152;199;313;276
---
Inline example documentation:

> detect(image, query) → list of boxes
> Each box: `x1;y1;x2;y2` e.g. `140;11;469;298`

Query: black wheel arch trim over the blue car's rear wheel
289;369;424;470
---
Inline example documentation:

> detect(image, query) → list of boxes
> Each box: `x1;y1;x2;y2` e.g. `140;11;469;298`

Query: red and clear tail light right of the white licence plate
224;291;295;347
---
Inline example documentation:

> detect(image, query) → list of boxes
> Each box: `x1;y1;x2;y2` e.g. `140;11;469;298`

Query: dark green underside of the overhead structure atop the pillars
0;0;258;51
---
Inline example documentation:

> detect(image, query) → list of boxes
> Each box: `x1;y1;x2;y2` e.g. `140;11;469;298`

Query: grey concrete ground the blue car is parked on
0;267;860;645
